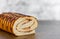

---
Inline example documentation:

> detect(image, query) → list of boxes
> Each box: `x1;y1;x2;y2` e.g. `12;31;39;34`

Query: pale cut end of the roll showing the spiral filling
13;17;38;36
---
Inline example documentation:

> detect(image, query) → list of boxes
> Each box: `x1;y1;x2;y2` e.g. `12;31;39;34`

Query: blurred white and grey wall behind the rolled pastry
0;0;60;20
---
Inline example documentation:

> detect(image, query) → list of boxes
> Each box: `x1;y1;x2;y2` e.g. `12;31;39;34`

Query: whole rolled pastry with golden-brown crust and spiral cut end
0;12;38;36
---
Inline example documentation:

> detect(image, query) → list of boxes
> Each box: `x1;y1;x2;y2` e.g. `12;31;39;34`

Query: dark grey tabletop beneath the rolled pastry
0;21;60;39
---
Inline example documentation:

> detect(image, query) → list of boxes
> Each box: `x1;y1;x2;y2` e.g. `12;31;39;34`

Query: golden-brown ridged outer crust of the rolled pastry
0;12;31;32
